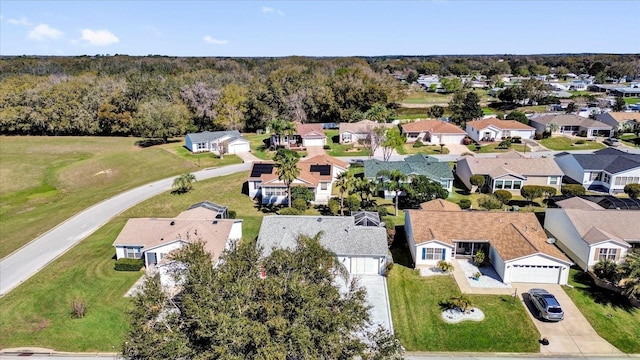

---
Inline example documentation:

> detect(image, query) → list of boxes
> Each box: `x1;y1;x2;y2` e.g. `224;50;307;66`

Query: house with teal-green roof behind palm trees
364;154;454;198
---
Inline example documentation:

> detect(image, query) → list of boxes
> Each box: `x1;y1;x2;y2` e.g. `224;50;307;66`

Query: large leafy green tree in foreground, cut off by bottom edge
122;233;401;359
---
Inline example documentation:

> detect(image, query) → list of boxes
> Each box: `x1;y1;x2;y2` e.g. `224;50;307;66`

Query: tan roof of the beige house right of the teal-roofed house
458;157;564;178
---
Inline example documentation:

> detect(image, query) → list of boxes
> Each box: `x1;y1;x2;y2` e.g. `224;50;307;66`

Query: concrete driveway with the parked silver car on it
512;283;623;356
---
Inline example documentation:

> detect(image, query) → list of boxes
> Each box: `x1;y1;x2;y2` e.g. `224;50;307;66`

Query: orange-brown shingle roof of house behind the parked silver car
405;210;571;263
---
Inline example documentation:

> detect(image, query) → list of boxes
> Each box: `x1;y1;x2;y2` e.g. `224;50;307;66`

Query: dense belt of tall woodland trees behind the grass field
0;56;404;140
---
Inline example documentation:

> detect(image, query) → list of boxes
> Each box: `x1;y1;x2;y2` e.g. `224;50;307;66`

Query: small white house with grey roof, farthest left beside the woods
184;130;251;154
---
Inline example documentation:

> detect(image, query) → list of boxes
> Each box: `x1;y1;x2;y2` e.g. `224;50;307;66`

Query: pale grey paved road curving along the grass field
0;163;251;297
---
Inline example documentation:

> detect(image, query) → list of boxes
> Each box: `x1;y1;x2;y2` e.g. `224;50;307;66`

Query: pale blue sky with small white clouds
0;0;640;57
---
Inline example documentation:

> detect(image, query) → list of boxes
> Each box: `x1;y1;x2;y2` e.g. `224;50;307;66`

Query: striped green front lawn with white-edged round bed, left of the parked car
387;264;540;352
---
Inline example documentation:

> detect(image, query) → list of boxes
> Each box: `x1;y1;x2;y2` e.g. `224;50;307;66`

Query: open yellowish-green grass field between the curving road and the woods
0;136;239;257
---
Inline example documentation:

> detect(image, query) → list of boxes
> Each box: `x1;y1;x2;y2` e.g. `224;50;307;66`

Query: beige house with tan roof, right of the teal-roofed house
455;151;564;193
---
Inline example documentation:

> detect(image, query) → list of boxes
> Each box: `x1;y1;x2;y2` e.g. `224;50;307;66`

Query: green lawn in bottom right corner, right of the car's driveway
565;269;640;354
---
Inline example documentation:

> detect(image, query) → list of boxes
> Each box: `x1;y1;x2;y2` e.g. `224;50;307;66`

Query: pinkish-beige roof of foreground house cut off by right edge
560;207;640;245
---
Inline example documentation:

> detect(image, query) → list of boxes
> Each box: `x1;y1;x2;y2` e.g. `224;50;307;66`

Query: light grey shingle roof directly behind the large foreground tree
257;215;388;256
